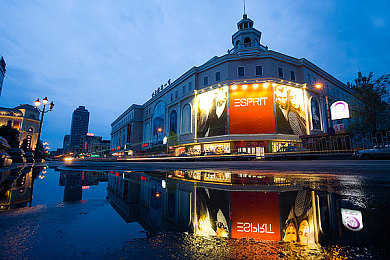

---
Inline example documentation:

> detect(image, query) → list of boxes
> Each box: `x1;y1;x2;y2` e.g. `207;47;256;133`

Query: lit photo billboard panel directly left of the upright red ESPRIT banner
196;87;228;138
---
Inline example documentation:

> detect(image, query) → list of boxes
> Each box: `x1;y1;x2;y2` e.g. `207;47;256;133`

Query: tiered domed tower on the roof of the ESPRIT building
232;14;267;52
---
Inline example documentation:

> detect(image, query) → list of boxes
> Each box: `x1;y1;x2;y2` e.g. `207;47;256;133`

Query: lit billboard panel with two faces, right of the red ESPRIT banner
274;85;307;135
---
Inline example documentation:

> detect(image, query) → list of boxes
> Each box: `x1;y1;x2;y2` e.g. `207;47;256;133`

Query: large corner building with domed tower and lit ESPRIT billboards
111;14;354;154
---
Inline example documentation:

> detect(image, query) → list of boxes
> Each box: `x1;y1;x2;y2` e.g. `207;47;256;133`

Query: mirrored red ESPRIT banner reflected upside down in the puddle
230;191;280;241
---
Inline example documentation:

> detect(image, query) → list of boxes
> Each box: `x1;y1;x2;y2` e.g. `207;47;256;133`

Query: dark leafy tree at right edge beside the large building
349;72;390;133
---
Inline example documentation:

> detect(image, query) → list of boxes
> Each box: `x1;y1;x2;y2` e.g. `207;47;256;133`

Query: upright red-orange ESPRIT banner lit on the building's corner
229;83;275;134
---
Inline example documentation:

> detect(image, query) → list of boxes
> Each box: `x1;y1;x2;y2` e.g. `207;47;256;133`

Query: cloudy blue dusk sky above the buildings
0;0;390;150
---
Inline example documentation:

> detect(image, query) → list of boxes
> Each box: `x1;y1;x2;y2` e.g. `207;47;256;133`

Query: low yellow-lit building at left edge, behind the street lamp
0;104;40;149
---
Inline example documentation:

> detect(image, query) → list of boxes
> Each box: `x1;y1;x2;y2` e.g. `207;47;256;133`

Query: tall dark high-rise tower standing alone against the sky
70;106;89;152
